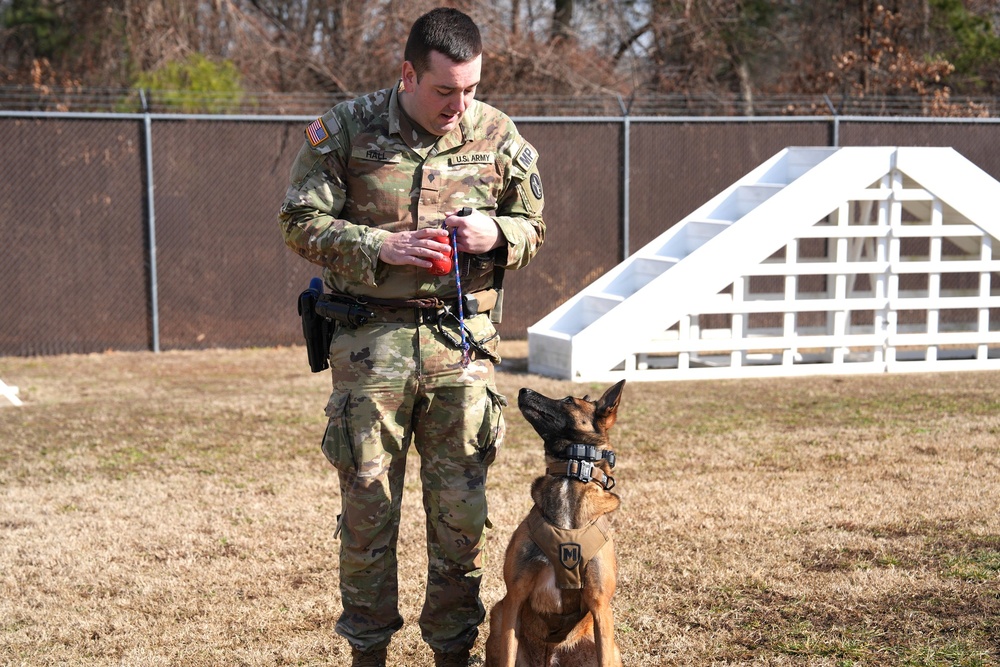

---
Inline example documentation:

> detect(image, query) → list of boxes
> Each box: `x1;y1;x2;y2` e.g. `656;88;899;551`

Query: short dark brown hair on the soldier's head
403;7;483;79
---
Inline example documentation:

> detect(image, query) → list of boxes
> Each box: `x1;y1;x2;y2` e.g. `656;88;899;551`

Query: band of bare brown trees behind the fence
0;0;1000;113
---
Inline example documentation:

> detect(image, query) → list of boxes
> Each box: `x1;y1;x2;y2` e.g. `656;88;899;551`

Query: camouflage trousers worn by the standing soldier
323;315;506;652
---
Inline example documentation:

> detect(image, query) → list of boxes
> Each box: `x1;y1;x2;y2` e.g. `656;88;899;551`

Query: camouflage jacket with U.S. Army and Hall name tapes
279;86;545;299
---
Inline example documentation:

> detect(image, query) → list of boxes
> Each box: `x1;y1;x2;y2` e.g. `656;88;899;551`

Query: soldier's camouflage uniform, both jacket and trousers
279;81;545;652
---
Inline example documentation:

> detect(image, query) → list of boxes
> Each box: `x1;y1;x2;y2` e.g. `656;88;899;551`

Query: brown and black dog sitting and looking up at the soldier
486;380;625;667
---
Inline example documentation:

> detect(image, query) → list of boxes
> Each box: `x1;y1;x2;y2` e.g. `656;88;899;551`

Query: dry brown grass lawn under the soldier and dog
0;344;1000;666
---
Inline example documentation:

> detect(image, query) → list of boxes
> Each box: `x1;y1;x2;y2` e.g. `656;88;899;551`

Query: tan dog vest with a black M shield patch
527;505;611;590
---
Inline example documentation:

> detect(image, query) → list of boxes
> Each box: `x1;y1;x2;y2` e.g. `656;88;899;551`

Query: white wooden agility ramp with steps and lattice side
528;147;1000;382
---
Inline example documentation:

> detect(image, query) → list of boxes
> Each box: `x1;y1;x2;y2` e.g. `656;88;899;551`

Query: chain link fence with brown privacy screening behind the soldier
0;110;1000;355
